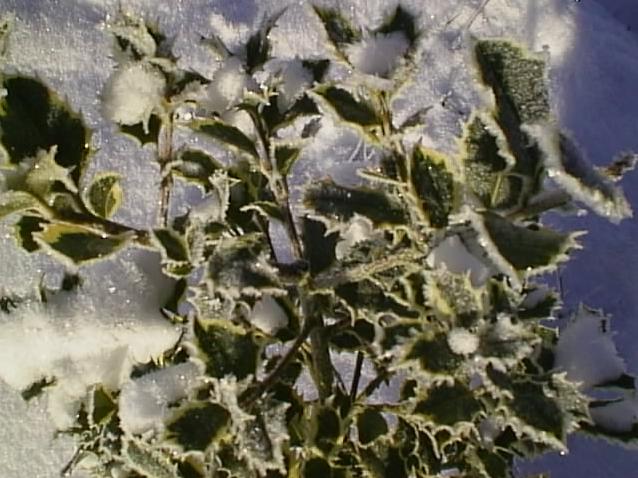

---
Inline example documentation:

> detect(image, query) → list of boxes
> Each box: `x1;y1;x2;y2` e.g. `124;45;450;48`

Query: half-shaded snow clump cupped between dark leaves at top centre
346;32;410;77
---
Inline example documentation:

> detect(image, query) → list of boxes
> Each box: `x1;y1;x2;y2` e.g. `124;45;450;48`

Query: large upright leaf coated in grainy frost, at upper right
475;40;550;124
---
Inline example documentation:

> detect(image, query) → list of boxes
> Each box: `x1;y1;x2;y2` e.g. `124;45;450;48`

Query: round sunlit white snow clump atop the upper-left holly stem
103;62;166;134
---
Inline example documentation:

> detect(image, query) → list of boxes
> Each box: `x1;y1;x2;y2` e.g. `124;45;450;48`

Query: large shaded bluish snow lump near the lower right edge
554;305;626;389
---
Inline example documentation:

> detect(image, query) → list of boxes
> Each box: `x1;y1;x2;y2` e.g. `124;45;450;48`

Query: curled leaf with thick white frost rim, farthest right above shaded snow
525;124;632;222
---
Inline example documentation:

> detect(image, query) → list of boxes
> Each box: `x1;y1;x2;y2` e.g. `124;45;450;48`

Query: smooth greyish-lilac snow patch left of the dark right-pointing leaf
427;236;491;287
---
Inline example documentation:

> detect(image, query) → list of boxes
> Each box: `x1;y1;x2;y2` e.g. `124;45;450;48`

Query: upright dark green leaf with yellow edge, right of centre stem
411;147;455;228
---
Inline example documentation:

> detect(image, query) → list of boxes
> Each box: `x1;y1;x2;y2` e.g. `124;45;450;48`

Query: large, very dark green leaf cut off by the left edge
0;76;90;184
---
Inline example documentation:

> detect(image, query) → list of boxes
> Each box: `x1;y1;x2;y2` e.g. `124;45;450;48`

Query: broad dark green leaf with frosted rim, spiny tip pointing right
483;213;576;271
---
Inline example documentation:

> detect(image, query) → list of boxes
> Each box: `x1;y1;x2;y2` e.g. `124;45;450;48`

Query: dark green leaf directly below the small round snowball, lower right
414;382;482;426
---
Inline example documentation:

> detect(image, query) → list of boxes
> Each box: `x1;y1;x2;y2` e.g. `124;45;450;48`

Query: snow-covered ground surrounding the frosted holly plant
0;0;638;478
